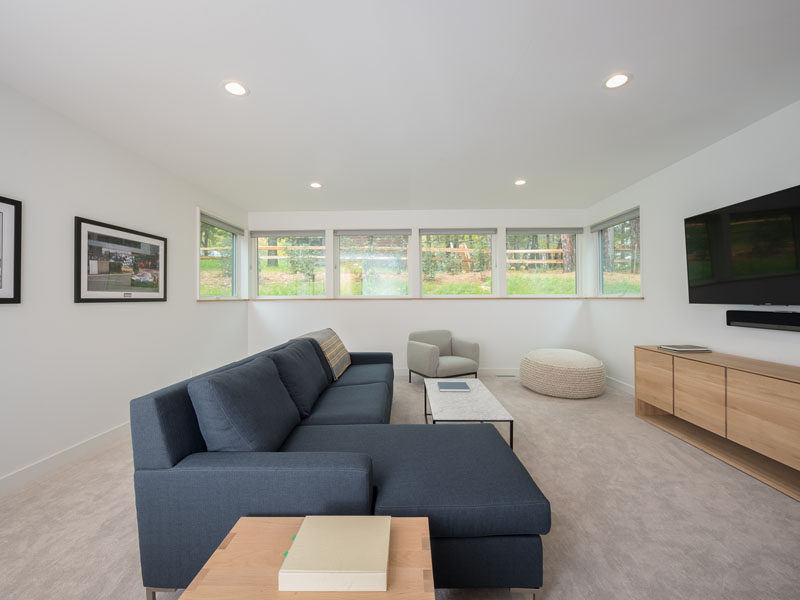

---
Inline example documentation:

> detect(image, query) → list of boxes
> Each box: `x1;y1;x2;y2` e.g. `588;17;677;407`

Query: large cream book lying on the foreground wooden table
278;515;391;592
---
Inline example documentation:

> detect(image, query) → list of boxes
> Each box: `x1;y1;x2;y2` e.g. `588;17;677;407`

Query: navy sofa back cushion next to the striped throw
270;339;328;418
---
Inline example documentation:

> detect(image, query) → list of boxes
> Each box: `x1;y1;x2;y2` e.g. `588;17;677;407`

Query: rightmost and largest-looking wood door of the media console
728;369;800;469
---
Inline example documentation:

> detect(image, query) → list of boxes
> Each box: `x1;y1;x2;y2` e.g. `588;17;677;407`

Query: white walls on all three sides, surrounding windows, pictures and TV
6;87;800;487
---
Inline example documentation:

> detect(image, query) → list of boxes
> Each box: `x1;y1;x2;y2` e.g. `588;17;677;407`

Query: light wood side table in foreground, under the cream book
181;517;435;600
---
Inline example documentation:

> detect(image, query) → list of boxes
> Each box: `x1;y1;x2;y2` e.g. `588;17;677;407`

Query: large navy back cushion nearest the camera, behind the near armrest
188;356;300;452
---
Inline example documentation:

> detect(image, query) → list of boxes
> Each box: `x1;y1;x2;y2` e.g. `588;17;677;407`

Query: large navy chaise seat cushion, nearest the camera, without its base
281;424;550;537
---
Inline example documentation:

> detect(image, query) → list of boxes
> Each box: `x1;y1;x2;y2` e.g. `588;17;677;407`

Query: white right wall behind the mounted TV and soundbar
588;102;800;383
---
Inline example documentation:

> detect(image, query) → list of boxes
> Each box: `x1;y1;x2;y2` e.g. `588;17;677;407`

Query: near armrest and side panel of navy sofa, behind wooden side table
134;452;372;588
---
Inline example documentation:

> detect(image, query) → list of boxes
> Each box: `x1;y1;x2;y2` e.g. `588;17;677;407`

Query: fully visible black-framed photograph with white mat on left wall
75;217;167;302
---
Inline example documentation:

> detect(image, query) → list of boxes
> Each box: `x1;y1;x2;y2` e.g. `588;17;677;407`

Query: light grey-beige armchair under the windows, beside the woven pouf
407;329;480;382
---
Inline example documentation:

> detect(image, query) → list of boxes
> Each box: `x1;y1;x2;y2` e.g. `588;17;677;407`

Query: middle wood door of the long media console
675;357;725;437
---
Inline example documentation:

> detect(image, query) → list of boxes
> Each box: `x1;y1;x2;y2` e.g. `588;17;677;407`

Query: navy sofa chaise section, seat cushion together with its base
281;424;550;588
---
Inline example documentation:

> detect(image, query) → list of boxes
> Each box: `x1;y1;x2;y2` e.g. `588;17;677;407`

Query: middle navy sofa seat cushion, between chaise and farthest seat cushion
300;383;392;425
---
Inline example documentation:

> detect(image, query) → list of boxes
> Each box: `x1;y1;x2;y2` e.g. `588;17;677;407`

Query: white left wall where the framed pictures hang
0;87;247;487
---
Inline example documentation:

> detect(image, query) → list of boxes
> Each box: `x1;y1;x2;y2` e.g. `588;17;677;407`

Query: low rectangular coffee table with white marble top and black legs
423;378;514;448
